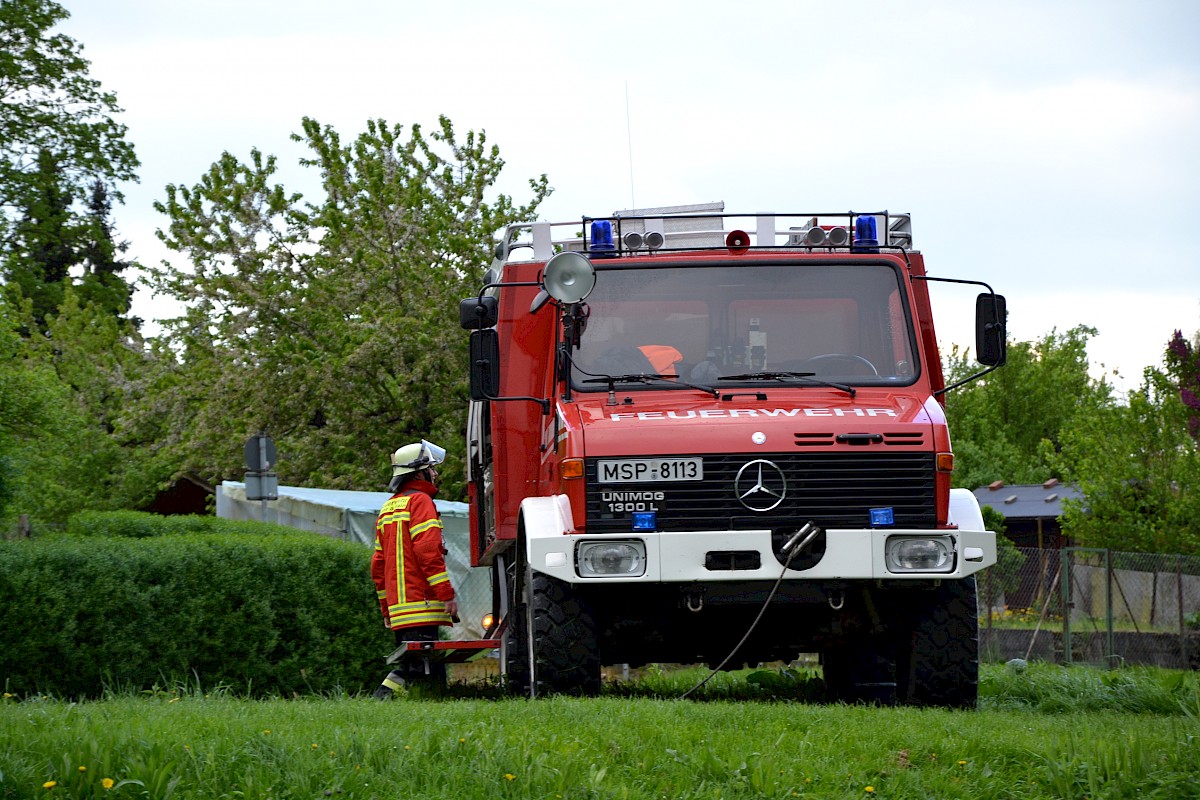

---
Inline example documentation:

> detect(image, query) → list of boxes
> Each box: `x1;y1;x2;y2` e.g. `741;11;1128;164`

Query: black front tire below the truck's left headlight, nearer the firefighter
528;571;600;697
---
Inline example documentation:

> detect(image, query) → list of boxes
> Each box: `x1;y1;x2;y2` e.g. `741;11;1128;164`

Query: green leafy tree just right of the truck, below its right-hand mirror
944;325;1114;488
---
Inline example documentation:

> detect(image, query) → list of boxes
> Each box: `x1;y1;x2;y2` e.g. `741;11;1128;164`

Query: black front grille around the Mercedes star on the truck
586;451;936;534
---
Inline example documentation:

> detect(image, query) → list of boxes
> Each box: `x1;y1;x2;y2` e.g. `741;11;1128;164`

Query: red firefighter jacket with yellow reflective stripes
371;479;454;630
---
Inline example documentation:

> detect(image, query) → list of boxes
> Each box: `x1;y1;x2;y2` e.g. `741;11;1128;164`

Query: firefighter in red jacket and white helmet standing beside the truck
371;439;458;700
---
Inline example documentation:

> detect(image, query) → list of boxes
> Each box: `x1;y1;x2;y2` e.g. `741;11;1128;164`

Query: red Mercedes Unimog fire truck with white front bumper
460;209;1004;706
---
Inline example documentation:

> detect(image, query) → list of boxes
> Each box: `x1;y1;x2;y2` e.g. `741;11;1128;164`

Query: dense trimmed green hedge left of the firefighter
0;515;392;698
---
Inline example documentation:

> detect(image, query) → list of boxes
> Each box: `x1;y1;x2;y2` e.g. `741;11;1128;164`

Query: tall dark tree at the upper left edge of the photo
0;0;138;327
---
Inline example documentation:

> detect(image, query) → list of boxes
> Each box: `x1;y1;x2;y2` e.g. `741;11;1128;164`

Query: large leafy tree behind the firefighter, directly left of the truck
138;118;550;497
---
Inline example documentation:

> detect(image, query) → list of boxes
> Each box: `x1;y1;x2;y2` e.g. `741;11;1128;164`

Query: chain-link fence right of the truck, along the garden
978;547;1200;668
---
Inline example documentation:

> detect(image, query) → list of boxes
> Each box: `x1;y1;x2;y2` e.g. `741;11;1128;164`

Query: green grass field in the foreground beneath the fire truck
0;664;1200;800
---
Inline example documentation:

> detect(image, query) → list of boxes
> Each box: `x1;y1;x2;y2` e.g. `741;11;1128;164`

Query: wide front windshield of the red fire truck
572;264;918;391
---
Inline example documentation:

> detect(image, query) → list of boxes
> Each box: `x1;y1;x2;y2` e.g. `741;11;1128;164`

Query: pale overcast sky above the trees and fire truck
60;0;1200;390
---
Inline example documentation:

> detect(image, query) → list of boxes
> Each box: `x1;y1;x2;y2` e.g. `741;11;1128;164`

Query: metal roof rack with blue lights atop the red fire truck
496;203;912;264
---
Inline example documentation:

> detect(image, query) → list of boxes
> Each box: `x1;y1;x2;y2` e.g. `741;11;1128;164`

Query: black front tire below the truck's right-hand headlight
896;576;979;709
